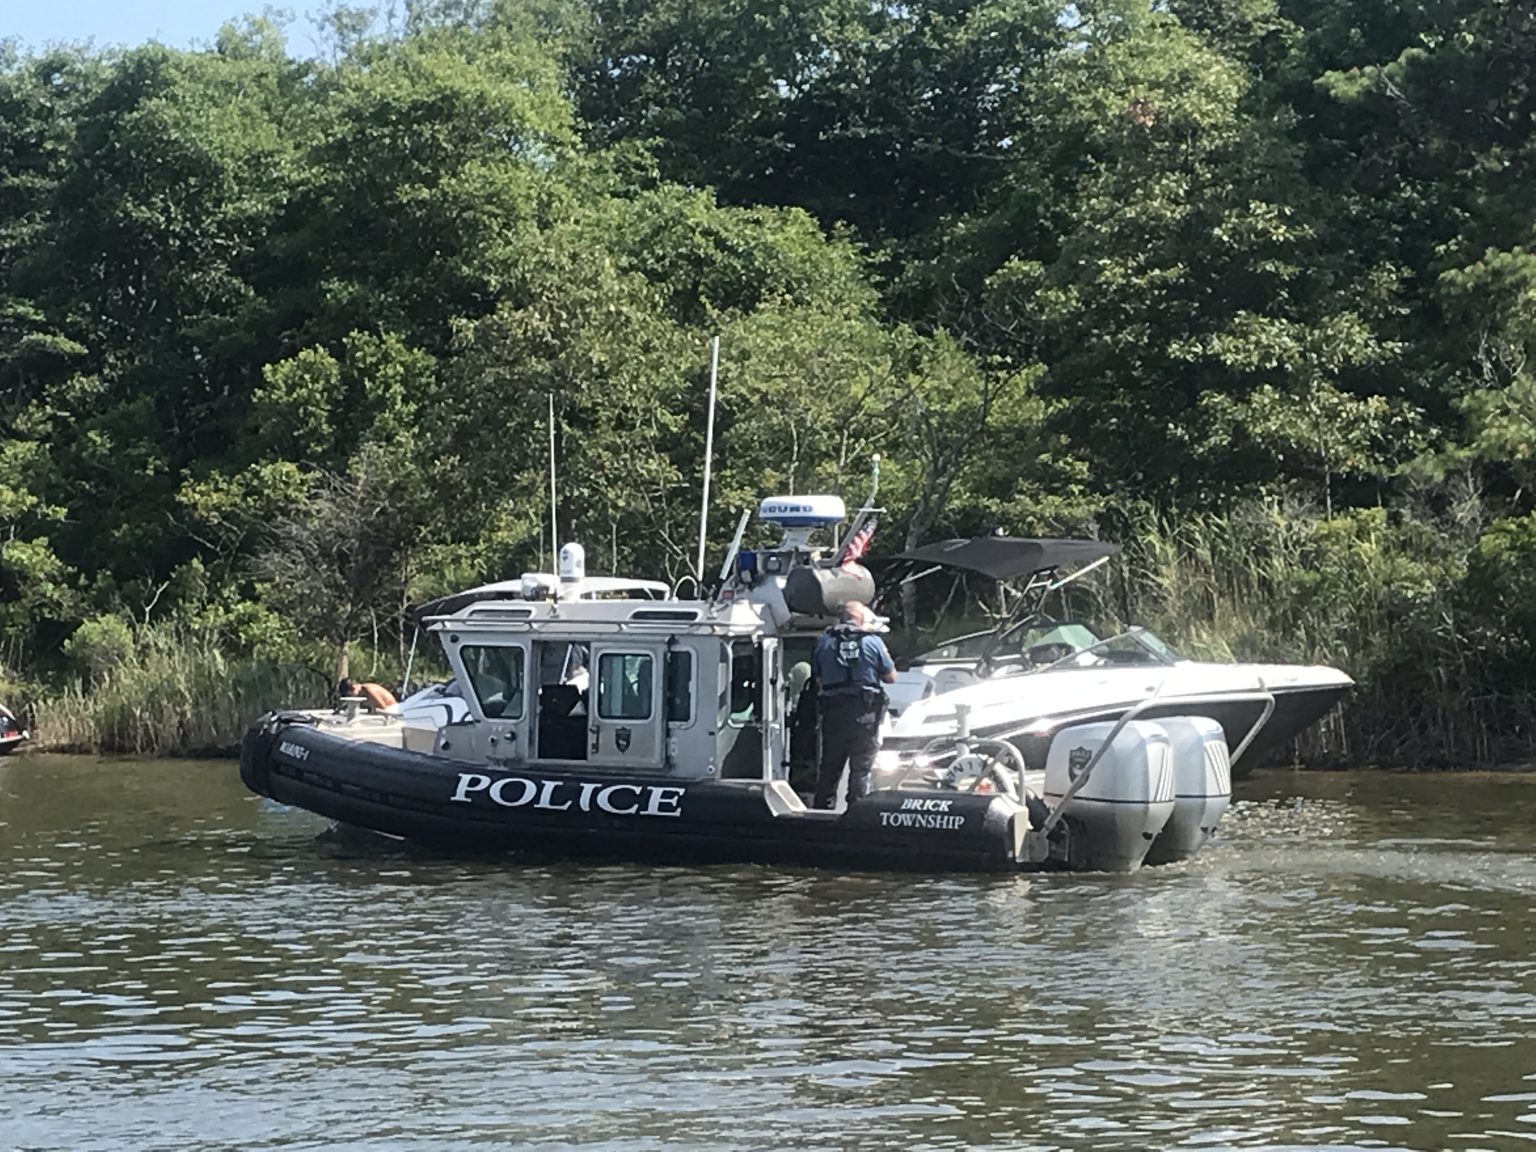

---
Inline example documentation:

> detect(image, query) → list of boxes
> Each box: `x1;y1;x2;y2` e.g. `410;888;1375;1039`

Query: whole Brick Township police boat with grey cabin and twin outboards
241;496;1273;871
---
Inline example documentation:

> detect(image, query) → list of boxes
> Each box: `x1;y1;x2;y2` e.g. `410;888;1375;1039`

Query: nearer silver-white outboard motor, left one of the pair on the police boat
1044;720;1174;872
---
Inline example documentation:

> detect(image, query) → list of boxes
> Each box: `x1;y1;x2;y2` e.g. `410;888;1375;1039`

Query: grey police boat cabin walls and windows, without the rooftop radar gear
432;601;783;777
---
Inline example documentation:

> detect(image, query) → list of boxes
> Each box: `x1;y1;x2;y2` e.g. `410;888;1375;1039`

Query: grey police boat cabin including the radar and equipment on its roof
427;496;872;780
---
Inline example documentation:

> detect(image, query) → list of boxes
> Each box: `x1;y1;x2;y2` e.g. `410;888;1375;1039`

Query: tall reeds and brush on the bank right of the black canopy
1118;504;1536;768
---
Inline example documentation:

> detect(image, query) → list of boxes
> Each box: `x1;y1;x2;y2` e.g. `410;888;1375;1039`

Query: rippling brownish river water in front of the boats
0;757;1536;1152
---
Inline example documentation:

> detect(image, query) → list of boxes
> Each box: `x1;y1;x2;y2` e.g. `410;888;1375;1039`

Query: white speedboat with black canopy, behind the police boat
885;536;1355;776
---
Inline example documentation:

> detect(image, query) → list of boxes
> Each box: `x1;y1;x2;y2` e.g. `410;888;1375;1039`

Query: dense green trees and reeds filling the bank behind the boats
0;0;1536;763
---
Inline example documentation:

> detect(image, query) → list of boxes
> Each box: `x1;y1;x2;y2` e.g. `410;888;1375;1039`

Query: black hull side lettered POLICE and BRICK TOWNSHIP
240;714;1060;871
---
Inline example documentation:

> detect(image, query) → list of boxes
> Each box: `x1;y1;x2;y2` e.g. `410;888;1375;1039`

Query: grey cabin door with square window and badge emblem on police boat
587;642;667;770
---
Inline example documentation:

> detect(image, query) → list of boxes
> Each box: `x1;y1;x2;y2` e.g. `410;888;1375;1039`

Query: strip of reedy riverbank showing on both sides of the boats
0;502;1536;771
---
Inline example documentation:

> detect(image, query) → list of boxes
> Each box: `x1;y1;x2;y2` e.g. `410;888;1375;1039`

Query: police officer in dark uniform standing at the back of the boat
811;601;895;808
